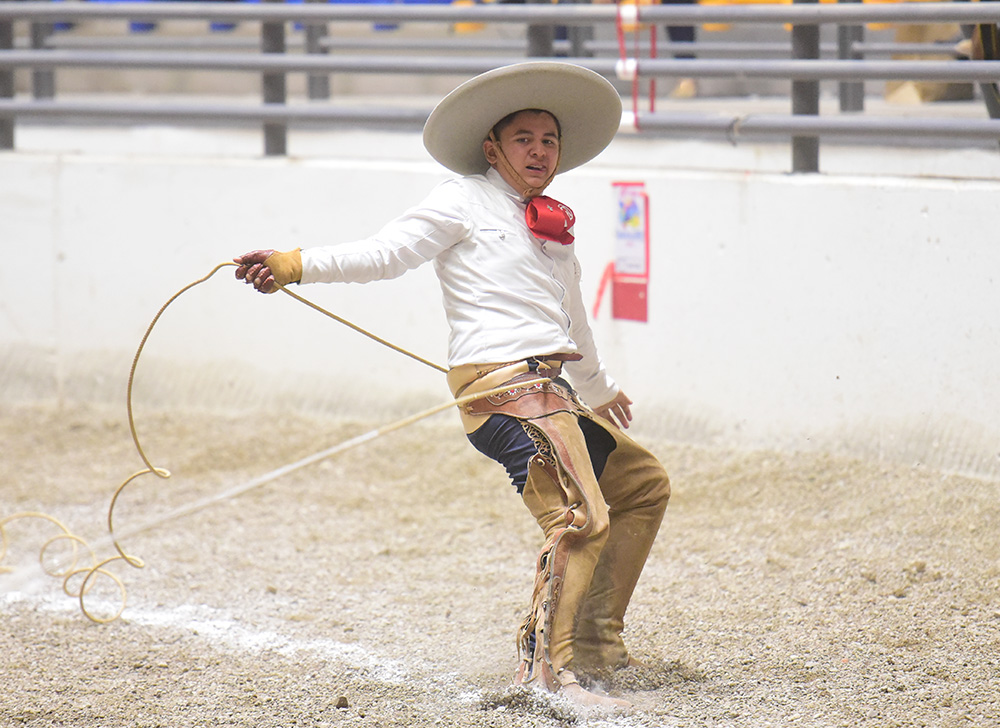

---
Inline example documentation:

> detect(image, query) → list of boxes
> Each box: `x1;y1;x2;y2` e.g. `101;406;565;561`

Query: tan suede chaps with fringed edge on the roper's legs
449;357;670;691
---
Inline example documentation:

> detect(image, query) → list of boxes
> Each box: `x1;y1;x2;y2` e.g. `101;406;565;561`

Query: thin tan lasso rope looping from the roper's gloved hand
0;262;549;624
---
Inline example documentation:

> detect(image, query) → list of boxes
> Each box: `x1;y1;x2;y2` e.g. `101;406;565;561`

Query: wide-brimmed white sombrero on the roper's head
424;61;622;174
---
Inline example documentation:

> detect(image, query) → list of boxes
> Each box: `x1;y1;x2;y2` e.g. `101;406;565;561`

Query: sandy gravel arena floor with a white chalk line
0;405;1000;728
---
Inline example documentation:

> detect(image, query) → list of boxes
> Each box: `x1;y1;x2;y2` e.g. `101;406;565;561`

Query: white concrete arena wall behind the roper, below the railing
0;133;1000;479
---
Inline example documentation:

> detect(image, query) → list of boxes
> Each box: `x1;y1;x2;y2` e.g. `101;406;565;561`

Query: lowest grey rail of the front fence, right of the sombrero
638;112;1000;141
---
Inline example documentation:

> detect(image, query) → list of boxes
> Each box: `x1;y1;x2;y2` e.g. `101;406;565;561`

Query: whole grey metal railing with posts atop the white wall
0;0;1000;172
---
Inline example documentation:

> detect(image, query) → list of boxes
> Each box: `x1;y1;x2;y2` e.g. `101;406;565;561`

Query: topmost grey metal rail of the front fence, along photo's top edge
0;0;1000;25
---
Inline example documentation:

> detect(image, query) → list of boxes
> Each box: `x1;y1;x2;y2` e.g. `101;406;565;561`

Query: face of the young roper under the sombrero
483;111;559;189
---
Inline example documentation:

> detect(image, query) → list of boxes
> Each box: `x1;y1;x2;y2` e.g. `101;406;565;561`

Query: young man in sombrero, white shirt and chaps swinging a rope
235;62;670;706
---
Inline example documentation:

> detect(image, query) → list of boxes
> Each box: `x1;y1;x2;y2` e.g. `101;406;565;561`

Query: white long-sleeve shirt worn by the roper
302;169;618;407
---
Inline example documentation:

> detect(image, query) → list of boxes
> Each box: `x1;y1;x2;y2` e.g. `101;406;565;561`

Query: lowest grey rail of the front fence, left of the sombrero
0;99;430;129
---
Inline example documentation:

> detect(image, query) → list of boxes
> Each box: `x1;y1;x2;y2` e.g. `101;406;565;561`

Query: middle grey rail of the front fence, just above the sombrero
0;50;1000;82
